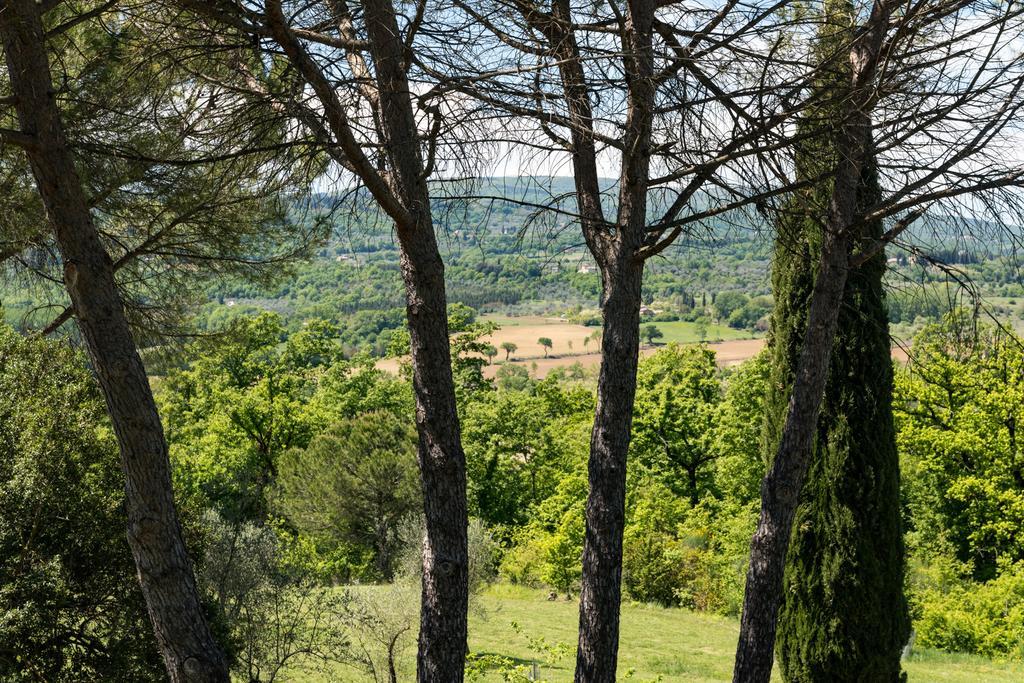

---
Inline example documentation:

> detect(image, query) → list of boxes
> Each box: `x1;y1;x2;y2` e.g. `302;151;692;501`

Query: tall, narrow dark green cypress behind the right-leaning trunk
764;0;909;683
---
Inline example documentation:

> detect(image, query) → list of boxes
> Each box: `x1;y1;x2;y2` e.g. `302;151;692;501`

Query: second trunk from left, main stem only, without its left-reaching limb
364;0;469;683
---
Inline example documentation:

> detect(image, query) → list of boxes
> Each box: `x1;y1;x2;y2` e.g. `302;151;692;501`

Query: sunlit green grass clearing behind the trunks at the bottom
287;585;1024;683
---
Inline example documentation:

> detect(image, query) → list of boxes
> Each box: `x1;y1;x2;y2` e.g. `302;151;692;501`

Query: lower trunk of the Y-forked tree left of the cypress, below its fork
575;253;643;683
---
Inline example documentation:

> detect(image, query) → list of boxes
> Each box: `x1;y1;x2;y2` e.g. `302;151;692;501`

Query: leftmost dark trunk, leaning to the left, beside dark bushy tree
0;0;228;683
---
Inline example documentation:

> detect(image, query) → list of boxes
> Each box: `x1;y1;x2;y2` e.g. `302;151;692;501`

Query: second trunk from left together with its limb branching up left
266;0;469;671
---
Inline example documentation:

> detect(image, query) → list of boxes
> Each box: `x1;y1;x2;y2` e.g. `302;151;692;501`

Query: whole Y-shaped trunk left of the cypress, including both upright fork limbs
573;0;655;683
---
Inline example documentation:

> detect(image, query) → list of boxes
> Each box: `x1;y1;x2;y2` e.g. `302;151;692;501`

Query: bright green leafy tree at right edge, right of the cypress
895;312;1024;581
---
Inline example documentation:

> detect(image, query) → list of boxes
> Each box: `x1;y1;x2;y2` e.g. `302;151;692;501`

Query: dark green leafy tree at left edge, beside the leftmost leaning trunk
0;326;166;683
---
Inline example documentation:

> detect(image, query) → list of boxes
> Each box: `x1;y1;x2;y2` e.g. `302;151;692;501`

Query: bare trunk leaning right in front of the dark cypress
733;0;891;683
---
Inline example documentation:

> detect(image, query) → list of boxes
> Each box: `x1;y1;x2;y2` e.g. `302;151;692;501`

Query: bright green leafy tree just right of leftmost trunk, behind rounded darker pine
161;313;323;522
